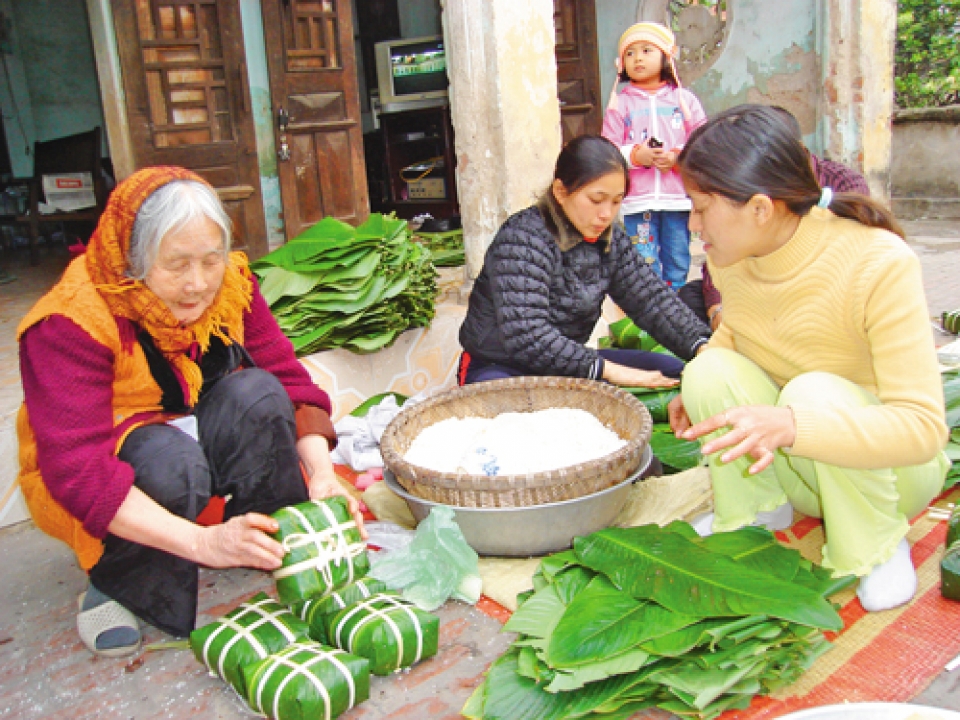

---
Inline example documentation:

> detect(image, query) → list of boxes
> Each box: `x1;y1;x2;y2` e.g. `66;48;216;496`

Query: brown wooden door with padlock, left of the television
261;0;370;240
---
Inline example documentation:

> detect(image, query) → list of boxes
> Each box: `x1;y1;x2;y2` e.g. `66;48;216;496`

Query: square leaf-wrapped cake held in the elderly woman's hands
273;496;370;605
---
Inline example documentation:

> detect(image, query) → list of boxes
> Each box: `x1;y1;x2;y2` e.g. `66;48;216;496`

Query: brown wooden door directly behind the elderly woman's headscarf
112;0;268;258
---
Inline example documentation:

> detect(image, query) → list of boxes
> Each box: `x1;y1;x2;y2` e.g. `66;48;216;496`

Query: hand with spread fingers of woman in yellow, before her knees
671;405;797;475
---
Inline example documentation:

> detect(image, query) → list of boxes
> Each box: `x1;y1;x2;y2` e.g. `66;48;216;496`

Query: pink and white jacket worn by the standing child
603;83;707;215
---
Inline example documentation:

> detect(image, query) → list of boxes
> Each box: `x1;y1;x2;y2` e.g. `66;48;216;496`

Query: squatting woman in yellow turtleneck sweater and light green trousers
670;106;948;610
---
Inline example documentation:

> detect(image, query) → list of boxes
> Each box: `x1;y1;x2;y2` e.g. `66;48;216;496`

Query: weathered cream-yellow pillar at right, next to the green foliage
817;0;897;203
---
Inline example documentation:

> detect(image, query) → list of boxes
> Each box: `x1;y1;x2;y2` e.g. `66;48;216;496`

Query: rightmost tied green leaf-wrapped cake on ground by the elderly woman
327;593;440;675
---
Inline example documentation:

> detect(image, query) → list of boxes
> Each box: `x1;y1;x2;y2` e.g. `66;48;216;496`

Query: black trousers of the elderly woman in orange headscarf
90;368;307;637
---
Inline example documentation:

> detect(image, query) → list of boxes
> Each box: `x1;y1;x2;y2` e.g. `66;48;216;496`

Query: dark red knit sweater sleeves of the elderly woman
20;281;336;538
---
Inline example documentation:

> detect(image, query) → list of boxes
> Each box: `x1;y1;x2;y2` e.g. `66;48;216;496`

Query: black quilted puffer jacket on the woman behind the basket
460;193;710;379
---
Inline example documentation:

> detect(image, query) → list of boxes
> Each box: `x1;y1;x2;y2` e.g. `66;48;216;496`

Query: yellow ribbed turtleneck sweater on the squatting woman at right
709;208;948;469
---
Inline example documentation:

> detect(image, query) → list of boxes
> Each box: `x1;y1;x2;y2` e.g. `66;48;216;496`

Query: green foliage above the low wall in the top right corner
895;0;960;108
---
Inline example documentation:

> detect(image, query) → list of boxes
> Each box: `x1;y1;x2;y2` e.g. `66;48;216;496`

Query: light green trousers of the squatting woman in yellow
682;349;950;575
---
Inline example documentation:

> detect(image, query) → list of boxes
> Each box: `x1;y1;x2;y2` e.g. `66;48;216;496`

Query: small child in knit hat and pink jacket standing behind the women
603;22;706;290
